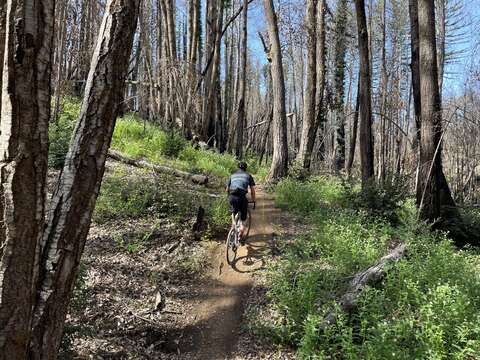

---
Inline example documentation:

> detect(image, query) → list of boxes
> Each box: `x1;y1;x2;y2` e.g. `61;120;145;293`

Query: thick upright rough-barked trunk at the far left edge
0;0;55;360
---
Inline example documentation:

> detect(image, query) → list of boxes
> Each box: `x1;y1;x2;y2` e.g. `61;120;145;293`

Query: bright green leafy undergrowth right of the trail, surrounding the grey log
250;177;480;359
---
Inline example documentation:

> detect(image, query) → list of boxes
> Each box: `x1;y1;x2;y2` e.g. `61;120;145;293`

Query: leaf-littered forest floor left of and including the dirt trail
61;162;299;360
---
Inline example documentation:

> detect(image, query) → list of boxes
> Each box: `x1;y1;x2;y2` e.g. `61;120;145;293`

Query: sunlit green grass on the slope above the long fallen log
49;97;268;181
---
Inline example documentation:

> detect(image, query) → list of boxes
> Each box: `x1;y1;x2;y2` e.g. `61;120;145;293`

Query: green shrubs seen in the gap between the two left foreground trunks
48;98;81;169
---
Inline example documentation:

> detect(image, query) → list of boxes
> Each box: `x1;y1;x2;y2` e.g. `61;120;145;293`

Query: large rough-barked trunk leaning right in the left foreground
30;0;140;359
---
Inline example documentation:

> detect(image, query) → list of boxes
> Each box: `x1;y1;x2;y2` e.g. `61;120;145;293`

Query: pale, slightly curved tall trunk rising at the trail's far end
263;0;288;181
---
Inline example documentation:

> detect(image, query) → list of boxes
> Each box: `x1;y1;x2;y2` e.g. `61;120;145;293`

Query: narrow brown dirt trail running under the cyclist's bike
179;191;278;360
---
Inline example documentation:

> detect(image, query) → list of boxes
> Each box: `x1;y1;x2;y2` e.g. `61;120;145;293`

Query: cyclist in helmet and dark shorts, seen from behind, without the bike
226;161;255;245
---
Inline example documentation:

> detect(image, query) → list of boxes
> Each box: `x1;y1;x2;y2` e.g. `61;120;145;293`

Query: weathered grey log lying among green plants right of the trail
320;243;405;330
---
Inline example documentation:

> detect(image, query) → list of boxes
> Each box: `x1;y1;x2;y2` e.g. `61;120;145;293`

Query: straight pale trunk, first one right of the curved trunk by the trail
297;0;316;169
